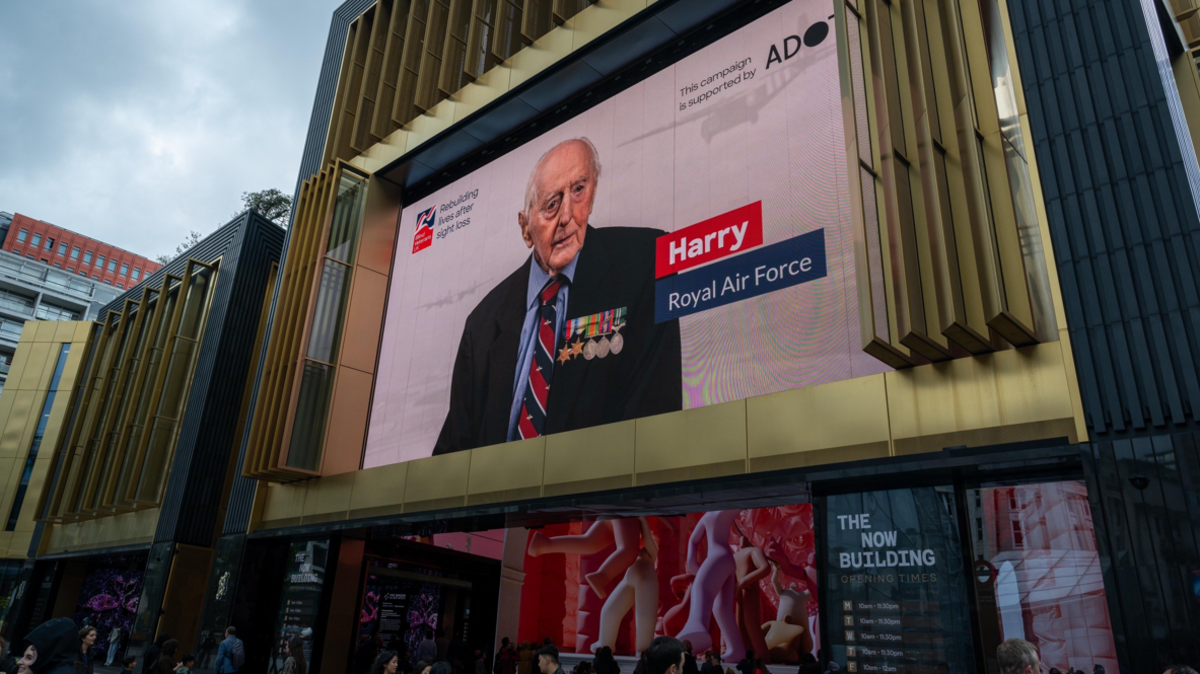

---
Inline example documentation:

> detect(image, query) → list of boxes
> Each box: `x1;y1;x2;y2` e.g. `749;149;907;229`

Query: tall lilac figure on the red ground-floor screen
676;510;745;662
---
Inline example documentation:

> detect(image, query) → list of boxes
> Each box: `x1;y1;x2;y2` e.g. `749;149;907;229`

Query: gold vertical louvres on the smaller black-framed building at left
38;259;218;522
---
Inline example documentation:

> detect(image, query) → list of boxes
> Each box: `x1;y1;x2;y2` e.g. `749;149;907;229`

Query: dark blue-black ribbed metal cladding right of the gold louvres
1008;0;1200;437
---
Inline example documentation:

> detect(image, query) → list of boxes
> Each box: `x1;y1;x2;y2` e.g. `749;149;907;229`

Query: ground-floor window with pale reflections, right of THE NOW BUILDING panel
966;480;1117;672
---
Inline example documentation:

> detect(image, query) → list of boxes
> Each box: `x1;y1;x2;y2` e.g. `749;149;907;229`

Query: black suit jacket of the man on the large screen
433;227;683;455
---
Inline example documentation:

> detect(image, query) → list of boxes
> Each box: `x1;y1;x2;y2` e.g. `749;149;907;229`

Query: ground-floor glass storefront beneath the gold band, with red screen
255;472;1117;674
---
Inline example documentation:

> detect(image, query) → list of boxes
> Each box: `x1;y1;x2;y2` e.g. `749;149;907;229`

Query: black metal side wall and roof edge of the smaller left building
101;211;283;547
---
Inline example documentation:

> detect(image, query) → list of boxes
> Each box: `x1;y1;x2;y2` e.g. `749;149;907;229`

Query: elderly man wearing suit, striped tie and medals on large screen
433;138;683;455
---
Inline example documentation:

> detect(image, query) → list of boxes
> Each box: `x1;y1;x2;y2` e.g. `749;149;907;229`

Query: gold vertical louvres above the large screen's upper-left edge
323;0;594;164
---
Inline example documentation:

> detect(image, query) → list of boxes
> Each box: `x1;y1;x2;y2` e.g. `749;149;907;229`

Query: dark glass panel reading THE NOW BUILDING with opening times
824;487;974;674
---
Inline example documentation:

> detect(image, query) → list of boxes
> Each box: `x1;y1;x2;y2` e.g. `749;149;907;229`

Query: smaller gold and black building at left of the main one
0;212;283;660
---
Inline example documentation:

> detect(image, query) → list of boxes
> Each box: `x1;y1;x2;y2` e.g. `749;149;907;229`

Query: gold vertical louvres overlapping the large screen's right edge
836;0;1055;367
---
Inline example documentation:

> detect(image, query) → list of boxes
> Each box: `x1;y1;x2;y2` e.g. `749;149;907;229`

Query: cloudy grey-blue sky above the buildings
0;0;341;257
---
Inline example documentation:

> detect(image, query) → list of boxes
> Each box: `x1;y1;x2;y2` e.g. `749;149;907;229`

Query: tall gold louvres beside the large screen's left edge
242;162;370;480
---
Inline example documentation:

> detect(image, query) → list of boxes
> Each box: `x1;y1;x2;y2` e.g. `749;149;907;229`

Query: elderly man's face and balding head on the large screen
517;142;596;275
